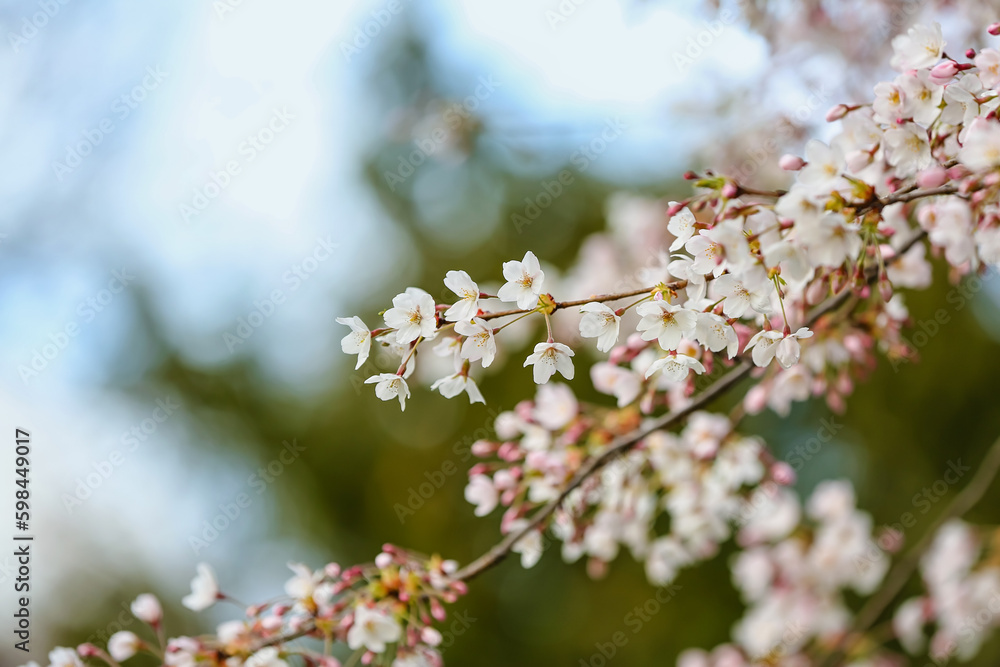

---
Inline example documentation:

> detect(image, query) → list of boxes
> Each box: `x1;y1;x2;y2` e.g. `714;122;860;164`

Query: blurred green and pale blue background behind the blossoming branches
0;0;1000;667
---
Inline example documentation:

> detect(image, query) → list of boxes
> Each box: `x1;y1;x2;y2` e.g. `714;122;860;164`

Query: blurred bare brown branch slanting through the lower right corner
820;439;1000;667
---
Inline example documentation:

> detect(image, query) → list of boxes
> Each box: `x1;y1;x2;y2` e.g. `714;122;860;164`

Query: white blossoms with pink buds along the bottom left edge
24;544;466;667
